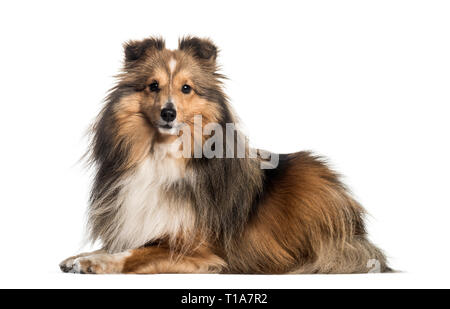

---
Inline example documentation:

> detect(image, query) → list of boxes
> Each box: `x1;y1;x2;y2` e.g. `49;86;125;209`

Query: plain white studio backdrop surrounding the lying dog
0;0;450;288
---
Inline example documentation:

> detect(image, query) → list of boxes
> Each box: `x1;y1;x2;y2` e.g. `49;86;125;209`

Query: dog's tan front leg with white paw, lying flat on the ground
63;246;225;274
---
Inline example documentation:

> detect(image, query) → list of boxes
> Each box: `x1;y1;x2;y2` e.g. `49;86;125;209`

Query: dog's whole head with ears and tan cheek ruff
93;37;233;167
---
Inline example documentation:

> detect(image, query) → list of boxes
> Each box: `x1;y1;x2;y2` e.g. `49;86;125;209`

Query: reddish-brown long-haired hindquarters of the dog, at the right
223;152;386;273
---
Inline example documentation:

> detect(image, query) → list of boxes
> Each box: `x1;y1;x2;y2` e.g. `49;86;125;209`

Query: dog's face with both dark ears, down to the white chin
118;38;225;135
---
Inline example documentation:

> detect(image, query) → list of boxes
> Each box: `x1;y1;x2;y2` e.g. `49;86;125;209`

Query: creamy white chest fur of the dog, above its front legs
111;145;194;251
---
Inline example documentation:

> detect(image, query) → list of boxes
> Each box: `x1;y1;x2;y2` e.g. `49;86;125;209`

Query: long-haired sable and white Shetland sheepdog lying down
60;37;390;274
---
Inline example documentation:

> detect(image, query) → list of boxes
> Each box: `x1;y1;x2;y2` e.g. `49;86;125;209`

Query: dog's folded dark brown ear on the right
178;37;218;63
